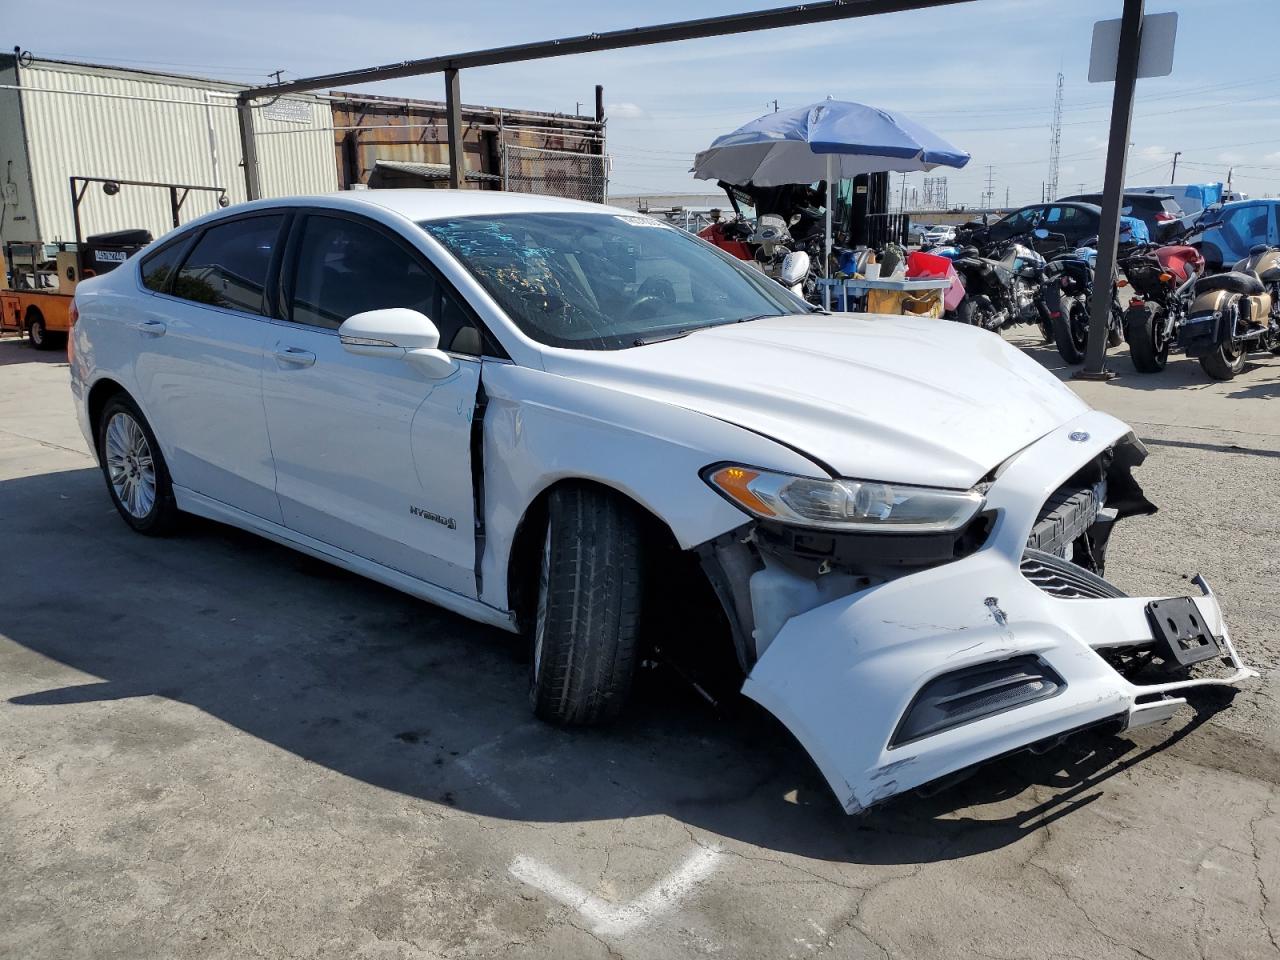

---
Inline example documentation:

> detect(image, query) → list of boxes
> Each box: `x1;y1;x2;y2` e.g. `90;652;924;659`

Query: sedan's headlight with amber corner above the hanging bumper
703;463;983;534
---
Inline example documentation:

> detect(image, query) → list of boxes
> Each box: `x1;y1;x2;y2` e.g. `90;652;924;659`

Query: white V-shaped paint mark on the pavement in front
509;847;719;937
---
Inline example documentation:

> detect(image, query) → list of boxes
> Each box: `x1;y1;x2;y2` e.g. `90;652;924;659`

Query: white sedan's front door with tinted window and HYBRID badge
264;214;480;596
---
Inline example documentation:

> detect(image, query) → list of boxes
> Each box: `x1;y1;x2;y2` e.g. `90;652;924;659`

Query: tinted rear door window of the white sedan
173;215;284;314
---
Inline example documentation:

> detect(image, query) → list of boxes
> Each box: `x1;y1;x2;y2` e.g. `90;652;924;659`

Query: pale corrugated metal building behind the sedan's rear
0;54;338;243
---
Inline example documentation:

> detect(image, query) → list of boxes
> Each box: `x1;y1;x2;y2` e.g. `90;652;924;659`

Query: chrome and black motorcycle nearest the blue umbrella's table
947;232;1052;340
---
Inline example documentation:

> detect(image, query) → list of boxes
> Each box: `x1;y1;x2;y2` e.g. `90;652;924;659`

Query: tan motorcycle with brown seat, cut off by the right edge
1176;244;1280;380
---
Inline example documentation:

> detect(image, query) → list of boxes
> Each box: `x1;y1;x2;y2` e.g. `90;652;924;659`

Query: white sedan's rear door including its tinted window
133;212;288;522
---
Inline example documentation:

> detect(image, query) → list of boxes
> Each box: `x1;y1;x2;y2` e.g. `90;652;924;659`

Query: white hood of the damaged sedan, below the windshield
544;314;1088;489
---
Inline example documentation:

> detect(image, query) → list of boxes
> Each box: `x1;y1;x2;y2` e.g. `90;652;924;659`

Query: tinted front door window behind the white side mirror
289;215;479;353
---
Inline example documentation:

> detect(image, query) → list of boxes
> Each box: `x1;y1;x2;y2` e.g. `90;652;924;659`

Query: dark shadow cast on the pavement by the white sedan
0;468;1225;864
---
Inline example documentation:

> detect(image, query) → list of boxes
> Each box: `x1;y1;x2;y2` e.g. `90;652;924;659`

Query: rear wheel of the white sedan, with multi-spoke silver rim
97;393;178;536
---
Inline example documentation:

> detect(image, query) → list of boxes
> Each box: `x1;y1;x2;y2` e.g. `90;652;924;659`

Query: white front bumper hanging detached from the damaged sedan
742;412;1257;813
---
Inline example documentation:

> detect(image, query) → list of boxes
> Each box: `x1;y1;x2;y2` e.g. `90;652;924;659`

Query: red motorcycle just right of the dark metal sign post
1117;244;1204;374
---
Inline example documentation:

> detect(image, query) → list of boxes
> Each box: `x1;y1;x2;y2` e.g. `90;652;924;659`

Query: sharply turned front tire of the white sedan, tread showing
529;486;644;726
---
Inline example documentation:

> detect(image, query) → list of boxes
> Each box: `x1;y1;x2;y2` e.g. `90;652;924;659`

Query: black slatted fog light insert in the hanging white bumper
888;655;1066;748
